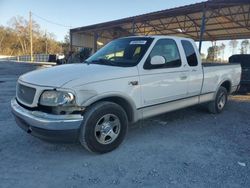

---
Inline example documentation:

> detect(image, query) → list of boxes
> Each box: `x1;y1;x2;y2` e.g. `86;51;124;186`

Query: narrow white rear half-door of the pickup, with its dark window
181;39;203;97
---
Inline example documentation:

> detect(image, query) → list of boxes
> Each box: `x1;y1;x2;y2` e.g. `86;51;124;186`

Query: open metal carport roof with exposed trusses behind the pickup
70;0;250;51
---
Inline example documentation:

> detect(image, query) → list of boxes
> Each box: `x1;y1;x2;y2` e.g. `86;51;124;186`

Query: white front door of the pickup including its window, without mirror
139;39;189;107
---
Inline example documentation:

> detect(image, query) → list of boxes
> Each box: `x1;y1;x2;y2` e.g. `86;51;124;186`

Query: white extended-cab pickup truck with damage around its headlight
11;36;241;153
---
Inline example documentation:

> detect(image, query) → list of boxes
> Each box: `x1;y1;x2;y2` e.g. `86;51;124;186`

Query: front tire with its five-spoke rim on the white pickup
79;101;128;153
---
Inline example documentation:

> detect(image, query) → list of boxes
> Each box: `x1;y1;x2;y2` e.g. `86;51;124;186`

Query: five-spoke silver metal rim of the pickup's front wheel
95;114;121;144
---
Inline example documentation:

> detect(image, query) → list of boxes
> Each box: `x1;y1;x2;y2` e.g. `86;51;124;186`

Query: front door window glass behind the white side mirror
144;39;181;69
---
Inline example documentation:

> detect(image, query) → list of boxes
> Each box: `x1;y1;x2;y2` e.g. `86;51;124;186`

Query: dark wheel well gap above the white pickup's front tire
93;97;134;122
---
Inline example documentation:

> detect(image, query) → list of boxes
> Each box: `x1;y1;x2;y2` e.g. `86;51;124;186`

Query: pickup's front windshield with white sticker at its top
86;37;153;67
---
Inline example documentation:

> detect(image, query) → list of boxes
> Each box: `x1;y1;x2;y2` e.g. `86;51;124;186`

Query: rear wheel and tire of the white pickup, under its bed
208;86;228;114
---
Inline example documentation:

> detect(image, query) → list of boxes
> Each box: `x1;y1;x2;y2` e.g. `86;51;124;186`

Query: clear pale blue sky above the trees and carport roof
0;0;247;58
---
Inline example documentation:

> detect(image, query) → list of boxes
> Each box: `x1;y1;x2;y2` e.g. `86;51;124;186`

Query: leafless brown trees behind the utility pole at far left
0;16;62;56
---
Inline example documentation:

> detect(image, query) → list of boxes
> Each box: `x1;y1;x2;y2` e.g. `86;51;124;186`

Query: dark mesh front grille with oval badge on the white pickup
17;83;36;104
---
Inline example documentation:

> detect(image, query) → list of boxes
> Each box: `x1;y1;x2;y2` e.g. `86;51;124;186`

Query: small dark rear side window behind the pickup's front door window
181;40;198;67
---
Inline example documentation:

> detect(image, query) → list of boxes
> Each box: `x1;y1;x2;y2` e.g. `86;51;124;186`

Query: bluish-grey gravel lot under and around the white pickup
0;62;250;188
